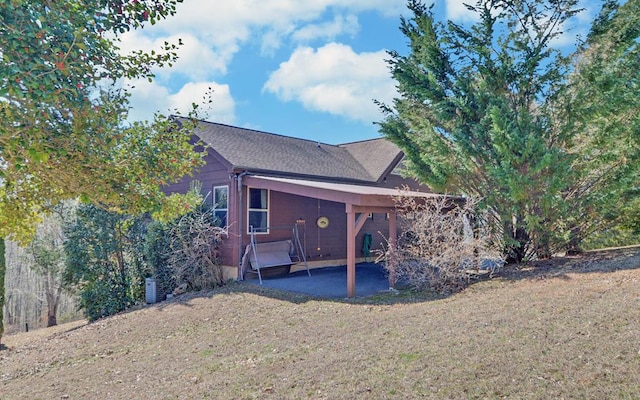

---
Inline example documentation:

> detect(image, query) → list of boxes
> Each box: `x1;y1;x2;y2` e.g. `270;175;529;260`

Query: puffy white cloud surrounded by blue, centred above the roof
263;43;396;122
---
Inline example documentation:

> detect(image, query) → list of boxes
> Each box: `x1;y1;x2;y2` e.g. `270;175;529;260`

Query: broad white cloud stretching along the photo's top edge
117;0;405;76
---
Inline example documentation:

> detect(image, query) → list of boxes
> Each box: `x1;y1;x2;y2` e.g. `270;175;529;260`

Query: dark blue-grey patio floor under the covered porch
246;262;396;298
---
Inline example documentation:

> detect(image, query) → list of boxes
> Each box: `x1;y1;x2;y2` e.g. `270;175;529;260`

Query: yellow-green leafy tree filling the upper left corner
0;0;202;340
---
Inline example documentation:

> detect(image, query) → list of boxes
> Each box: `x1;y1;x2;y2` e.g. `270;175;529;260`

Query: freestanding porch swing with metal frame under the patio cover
242;223;311;285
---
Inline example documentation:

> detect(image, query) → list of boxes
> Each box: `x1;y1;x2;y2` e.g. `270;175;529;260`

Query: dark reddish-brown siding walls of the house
166;159;430;279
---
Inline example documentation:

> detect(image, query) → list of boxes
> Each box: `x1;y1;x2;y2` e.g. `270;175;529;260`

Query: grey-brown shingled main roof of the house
194;121;403;183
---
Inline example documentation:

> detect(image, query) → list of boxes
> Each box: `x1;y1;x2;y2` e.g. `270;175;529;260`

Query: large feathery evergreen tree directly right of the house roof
380;0;637;262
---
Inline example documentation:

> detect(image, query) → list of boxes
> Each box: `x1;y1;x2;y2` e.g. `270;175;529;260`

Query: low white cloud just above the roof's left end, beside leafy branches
129;80;236;124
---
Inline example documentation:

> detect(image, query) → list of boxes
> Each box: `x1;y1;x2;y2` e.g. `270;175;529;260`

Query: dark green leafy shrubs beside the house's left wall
64;185;208;320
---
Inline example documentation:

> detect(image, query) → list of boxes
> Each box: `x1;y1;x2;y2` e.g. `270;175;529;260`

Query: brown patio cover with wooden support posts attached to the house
242;175;442;297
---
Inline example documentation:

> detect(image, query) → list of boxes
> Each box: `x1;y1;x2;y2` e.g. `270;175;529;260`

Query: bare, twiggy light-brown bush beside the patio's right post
384;194;503;293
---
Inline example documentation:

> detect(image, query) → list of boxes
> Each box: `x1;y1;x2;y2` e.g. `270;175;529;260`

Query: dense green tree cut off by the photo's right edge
556;0;640;247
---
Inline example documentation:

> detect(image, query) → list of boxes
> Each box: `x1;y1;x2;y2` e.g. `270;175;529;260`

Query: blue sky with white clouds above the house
120;0;597;144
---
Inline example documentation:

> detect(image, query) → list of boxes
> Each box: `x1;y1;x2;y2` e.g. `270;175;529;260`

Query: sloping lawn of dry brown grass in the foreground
0;245;640;399
